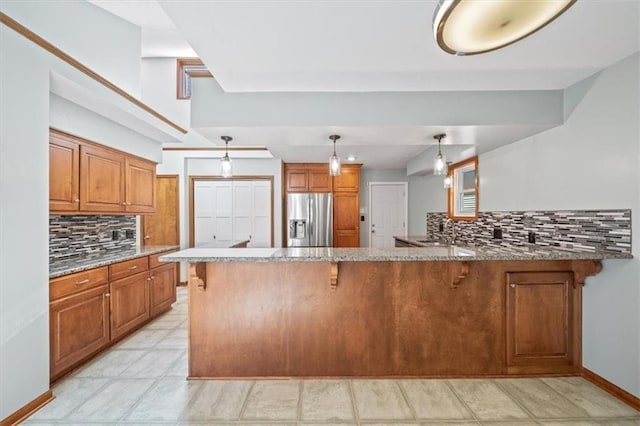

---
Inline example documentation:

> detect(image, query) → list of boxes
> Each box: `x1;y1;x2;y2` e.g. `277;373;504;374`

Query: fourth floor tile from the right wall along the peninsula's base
399;380;473;420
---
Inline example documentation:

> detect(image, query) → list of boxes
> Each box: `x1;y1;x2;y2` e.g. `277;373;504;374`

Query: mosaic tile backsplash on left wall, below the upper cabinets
49;215;136;263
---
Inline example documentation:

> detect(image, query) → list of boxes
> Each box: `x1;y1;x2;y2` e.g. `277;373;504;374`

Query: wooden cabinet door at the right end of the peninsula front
506;272;581;374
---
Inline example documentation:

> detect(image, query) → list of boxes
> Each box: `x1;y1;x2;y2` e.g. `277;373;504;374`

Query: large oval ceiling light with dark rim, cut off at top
433;0;576;56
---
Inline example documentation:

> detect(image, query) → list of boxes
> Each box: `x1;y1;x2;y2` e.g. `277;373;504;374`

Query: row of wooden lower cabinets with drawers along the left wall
49;252;177;380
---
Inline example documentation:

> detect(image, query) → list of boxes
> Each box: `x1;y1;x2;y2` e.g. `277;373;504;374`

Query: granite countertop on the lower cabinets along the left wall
49;246;180;278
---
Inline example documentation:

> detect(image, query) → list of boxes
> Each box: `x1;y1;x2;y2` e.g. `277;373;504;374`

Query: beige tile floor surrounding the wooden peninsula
26;288;640;426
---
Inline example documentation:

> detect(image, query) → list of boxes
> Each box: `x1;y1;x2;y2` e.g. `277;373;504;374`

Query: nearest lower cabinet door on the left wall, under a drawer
49;285;109;378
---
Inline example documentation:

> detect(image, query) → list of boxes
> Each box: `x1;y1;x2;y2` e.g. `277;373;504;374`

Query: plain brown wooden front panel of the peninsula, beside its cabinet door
189;261;596;378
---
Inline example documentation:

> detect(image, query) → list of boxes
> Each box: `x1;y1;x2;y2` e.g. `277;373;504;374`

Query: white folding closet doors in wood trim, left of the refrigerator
193;180;271;247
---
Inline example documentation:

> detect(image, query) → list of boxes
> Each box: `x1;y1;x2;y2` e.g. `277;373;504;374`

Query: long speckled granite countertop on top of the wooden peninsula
159;244;633;263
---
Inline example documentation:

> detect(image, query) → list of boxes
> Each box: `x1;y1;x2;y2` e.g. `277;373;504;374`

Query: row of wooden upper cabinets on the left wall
49;130;156;214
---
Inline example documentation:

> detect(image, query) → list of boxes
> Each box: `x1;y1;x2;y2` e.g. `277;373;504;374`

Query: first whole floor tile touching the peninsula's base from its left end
183;380;253;421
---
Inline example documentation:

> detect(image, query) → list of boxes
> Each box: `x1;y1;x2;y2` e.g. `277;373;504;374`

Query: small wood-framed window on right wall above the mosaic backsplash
447;157;478;220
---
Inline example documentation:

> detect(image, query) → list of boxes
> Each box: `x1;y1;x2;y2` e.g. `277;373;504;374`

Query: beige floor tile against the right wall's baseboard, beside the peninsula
542;377;640;417
